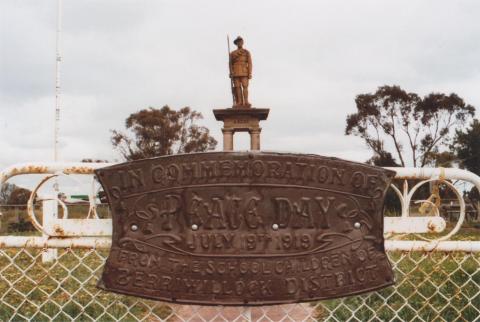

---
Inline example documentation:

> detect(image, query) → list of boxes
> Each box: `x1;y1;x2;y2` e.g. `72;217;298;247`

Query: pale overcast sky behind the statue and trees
0;0;480;175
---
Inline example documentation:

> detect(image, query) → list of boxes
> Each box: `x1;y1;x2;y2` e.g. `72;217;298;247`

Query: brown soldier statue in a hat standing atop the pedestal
229;36;252;107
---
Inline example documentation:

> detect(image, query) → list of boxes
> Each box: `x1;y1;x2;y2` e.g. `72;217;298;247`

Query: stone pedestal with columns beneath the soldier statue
213;107;270;151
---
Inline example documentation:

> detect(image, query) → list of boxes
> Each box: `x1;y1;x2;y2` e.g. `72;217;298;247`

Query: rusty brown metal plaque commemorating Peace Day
96;152;394;305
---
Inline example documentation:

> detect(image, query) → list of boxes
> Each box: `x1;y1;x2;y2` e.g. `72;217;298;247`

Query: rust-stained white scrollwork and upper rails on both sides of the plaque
0;163;480;240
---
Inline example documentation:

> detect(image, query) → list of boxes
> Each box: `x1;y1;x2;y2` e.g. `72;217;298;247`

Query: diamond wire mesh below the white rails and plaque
0;247;480;321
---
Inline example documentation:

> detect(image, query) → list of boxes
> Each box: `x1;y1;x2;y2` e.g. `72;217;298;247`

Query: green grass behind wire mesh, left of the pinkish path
0;249;172;321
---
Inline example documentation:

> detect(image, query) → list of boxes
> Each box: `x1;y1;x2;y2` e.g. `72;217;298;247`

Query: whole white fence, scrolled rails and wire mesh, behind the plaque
0;163;480;321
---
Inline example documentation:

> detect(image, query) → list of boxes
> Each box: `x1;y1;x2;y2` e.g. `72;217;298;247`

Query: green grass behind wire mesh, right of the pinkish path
315;252;480;321
